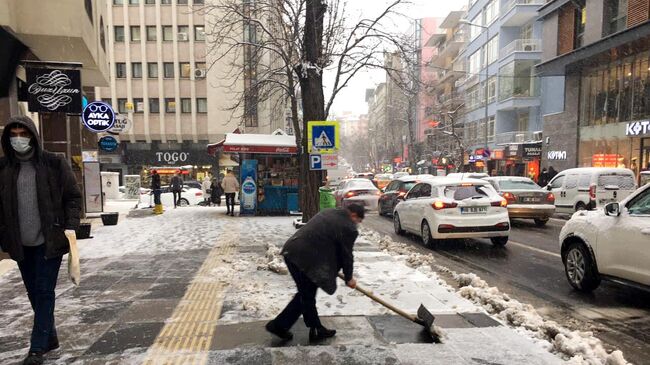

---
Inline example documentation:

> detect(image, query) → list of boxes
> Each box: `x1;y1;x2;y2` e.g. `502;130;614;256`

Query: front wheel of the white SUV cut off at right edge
562;242;600;292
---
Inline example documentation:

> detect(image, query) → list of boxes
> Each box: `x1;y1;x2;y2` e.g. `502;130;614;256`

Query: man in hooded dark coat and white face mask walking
0;116;81;365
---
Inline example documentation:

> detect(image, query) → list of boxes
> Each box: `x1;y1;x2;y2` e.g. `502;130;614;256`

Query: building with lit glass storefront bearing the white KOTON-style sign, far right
537;0;650;173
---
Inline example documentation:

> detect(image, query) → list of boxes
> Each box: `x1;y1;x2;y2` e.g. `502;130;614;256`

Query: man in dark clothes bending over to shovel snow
266;204;364;341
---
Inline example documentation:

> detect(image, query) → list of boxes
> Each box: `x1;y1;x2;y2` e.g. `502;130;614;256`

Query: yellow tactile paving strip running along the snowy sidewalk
143;228;239;365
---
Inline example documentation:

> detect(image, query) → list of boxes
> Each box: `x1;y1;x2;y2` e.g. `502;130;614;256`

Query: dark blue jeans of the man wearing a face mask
18;244;61;352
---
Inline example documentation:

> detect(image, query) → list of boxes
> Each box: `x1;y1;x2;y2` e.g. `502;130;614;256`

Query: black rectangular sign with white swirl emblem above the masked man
26;66;82;113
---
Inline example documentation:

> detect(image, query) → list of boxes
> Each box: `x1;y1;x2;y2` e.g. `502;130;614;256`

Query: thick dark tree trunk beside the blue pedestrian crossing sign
296;0;327;222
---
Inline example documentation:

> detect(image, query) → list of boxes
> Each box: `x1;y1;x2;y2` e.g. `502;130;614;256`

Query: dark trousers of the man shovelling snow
274;259;322;331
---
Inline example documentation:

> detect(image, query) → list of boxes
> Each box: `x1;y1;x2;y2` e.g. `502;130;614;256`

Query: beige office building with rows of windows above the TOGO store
98;0;285;179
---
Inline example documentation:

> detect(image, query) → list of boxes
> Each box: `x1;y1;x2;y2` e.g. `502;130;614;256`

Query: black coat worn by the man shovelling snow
282;209;359;295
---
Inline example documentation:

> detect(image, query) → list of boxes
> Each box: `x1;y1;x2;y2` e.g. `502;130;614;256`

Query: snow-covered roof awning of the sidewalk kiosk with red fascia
223;133;298;154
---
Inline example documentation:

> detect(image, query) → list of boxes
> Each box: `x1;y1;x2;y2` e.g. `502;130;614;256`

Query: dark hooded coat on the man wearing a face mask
0;117;81;261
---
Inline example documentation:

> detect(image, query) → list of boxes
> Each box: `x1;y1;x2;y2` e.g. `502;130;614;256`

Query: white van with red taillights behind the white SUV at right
546;167;637;213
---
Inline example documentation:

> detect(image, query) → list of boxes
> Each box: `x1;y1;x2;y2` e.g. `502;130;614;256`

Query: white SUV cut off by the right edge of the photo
560;185;650;292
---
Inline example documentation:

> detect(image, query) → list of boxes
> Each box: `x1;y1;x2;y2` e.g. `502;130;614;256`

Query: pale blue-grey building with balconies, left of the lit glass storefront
459;0;543;177
